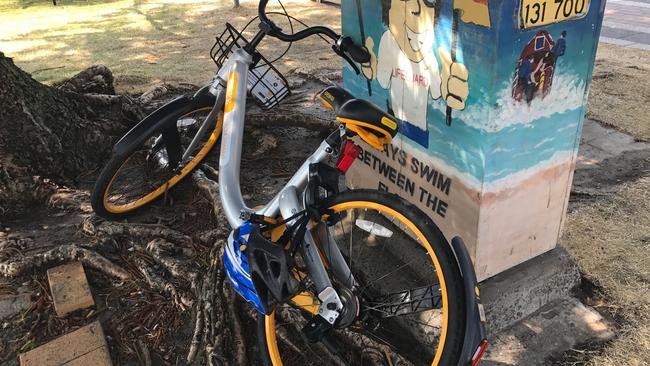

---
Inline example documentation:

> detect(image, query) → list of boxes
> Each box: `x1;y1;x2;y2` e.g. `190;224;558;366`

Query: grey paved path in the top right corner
600;0;650;50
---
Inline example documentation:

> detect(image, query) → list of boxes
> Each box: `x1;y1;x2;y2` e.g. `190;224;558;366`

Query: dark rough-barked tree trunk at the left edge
0;52;139;216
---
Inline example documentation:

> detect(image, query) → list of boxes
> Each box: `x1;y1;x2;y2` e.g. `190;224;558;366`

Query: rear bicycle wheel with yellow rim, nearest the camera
258;190;465;366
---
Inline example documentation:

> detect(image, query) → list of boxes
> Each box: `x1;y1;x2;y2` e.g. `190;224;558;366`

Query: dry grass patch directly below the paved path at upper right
587;43;650;141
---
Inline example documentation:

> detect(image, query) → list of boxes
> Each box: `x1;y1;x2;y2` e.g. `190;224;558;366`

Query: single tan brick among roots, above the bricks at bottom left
47;262;95;317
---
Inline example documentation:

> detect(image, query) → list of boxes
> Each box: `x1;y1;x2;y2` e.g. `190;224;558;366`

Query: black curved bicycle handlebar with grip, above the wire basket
258;0;370;70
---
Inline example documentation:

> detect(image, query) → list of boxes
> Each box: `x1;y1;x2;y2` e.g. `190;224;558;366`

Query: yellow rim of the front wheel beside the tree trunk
104;108;223;214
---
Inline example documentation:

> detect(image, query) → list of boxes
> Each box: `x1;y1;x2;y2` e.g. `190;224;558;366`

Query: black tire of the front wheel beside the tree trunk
90;98;220;220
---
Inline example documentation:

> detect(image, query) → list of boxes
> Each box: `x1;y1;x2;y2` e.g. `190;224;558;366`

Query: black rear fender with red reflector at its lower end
451;236;487;366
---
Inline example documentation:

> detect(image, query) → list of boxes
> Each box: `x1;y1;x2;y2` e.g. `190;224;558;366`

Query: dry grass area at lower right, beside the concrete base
561;176;650;366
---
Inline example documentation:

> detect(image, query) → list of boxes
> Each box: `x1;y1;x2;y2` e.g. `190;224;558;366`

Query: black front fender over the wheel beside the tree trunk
113;87;215;157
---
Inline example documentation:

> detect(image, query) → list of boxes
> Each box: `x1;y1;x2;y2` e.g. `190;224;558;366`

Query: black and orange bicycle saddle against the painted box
318;86;397;151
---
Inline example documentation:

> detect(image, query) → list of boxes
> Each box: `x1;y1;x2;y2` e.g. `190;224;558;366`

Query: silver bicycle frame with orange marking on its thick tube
210;49;353;324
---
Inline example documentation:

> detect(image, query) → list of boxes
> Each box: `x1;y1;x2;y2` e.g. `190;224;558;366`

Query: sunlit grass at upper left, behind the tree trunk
0;0;218;91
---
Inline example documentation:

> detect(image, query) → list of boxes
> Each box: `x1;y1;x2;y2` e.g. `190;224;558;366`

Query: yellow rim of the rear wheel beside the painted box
264;201;449;366
